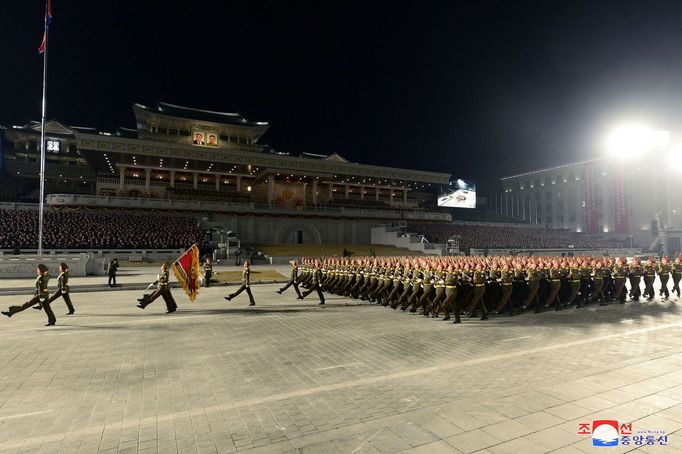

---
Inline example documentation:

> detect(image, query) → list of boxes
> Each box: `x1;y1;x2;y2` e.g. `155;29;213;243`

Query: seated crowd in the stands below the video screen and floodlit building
406;222;623;251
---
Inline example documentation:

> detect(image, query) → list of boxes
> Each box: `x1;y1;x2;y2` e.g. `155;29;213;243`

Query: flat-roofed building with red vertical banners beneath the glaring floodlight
494;158;682;255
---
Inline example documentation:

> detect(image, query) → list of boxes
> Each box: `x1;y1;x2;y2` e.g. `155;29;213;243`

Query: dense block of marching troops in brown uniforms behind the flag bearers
278;256;682;323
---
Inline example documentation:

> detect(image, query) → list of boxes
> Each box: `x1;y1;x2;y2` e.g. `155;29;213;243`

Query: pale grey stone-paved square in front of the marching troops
0;279;682;454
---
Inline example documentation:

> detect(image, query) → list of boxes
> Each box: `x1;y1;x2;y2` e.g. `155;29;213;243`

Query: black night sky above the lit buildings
0;0;682;189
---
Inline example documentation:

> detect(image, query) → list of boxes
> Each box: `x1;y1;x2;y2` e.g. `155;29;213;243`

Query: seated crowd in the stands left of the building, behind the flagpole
0;209;203;249
